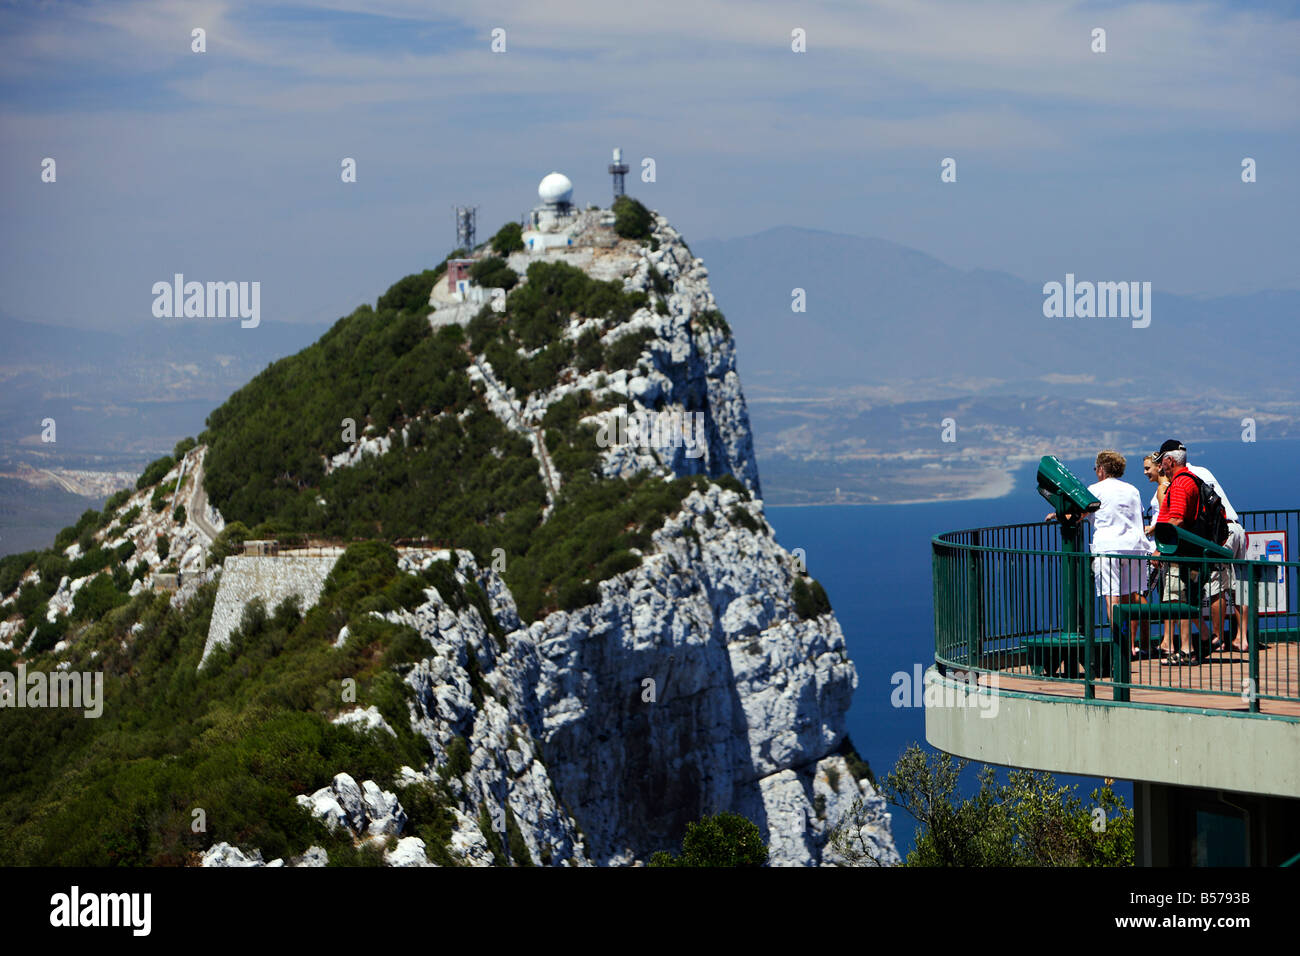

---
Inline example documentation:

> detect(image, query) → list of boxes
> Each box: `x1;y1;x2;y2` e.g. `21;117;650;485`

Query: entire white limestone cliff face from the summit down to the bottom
308;212;896;865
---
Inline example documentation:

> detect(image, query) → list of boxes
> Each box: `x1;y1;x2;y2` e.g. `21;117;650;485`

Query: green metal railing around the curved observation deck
932;510;1300;719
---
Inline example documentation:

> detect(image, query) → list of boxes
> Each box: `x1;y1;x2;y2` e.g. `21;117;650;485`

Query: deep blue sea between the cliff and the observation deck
759;437;1300;856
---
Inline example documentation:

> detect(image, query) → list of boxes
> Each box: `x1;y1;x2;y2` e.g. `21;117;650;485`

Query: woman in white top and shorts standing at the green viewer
1048;449;1156;657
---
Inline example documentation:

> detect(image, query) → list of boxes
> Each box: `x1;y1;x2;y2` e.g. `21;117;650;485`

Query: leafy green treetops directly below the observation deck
831;744;1134;866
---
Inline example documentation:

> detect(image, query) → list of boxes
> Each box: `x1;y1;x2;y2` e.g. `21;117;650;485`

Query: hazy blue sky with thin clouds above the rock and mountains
0;0;1300;328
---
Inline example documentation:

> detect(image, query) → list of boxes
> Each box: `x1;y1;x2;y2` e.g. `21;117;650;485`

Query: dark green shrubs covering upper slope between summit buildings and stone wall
192;259;717;620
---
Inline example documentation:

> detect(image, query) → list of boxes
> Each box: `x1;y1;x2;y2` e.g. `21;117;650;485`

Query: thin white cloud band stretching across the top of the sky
0;0;1300;138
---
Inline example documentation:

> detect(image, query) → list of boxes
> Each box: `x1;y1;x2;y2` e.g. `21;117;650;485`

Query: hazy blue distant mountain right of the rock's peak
692;226;1300;398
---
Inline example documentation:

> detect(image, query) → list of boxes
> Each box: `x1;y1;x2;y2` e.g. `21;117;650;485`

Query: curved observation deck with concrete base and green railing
924;510;1300;865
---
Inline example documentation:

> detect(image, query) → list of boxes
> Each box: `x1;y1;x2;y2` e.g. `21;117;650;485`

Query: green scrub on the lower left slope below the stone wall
0;542;468;866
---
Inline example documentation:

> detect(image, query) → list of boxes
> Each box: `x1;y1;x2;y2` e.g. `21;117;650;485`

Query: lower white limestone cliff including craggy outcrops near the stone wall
325;502;893;865
